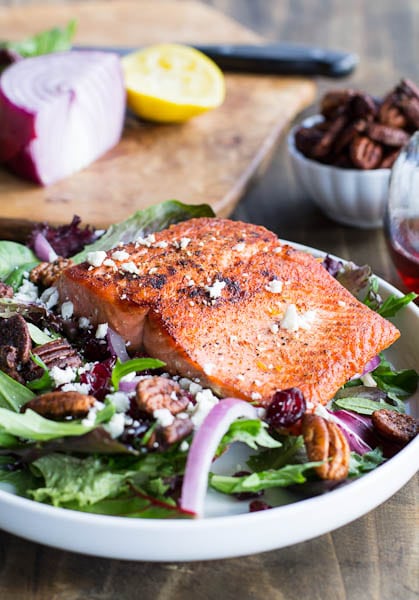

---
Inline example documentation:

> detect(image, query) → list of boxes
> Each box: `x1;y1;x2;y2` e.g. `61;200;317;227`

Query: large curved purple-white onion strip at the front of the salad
180;398;257;516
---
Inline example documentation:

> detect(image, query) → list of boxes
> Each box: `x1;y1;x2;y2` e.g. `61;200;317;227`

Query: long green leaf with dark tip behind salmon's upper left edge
72;200;214;263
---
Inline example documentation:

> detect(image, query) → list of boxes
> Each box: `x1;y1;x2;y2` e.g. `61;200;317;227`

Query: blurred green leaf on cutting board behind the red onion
0;20;76;58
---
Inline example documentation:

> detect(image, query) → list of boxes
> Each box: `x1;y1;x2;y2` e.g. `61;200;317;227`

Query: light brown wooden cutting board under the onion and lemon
0;0;315;239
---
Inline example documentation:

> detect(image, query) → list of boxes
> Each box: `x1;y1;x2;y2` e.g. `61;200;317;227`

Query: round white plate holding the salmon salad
0;244;419;561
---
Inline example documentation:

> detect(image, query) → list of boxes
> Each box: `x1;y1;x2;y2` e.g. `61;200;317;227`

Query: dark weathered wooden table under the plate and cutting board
0;0;419;600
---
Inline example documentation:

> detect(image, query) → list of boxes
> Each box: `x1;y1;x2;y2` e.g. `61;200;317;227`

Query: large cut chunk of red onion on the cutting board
0;51;125;185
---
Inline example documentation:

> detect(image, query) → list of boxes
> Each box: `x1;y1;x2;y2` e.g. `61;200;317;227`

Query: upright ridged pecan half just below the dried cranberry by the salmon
302;413;350;480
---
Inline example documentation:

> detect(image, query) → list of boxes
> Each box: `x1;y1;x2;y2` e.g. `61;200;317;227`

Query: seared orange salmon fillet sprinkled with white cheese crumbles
58;218;400;405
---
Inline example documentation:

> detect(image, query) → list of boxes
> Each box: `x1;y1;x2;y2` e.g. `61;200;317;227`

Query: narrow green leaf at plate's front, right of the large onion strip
209;462;322;494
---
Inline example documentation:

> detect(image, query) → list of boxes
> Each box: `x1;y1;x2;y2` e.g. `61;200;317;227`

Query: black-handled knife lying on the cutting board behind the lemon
74;43;358;77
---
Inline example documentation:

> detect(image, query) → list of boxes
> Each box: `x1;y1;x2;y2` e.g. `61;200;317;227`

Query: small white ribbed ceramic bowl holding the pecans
288;115;391;229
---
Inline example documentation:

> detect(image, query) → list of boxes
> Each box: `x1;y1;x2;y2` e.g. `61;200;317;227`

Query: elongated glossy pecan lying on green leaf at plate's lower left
22;391;96;421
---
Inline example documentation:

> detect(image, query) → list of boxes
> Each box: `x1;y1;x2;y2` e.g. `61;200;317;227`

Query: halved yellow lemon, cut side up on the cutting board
122;44;225;123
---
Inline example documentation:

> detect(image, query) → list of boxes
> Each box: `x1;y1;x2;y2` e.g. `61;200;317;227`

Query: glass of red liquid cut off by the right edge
384;131;419;293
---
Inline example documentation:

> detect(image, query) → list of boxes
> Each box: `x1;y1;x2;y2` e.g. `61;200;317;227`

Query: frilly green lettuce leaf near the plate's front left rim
28;454;134;506
